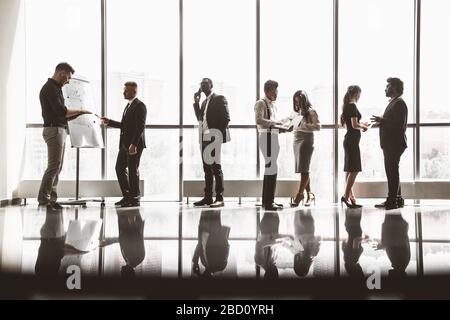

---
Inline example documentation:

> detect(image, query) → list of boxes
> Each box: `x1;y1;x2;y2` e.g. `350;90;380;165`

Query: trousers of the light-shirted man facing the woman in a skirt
259;132;280;206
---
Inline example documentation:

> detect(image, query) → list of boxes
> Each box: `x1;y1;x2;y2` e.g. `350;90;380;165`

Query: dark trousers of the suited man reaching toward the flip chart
116;146;143;199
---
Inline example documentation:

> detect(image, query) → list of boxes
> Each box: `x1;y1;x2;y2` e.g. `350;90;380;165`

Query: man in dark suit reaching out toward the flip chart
102;81;147;207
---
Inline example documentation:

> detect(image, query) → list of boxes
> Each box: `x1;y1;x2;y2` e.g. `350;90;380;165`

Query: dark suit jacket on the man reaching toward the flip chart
108;98;147;149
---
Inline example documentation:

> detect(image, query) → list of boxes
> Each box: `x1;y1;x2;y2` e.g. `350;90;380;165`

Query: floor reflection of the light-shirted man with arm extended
255;211;294;279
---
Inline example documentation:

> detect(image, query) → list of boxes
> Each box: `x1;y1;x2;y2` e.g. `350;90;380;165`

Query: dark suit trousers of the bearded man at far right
383;148;405;201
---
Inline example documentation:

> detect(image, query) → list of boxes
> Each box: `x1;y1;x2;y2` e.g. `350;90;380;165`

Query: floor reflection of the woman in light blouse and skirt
292;209;321;277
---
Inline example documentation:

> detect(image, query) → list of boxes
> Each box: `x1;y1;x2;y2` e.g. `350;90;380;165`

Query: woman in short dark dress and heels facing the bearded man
341;86;368;208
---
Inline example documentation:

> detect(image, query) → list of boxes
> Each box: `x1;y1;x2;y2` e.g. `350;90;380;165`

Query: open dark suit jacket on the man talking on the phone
194;93;231;143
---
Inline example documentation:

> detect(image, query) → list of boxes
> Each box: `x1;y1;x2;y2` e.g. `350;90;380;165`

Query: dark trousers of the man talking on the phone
202;141;224;198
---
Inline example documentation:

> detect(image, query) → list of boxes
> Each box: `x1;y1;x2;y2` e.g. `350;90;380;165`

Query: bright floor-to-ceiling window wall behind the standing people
21;0;450;202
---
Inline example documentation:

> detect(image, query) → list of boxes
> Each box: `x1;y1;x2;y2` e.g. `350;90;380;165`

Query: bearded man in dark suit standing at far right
371;78;408;210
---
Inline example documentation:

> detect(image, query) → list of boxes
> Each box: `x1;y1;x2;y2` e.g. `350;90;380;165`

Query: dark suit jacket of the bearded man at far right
380;97;408;150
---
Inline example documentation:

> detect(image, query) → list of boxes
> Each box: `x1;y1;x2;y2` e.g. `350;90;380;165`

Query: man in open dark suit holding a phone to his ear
194;78;231;208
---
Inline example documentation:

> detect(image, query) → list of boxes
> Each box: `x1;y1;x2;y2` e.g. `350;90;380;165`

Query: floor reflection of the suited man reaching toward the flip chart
106;208;145;277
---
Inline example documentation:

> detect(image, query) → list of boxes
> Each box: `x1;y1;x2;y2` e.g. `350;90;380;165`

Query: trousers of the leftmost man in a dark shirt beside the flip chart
38;127;67;204
